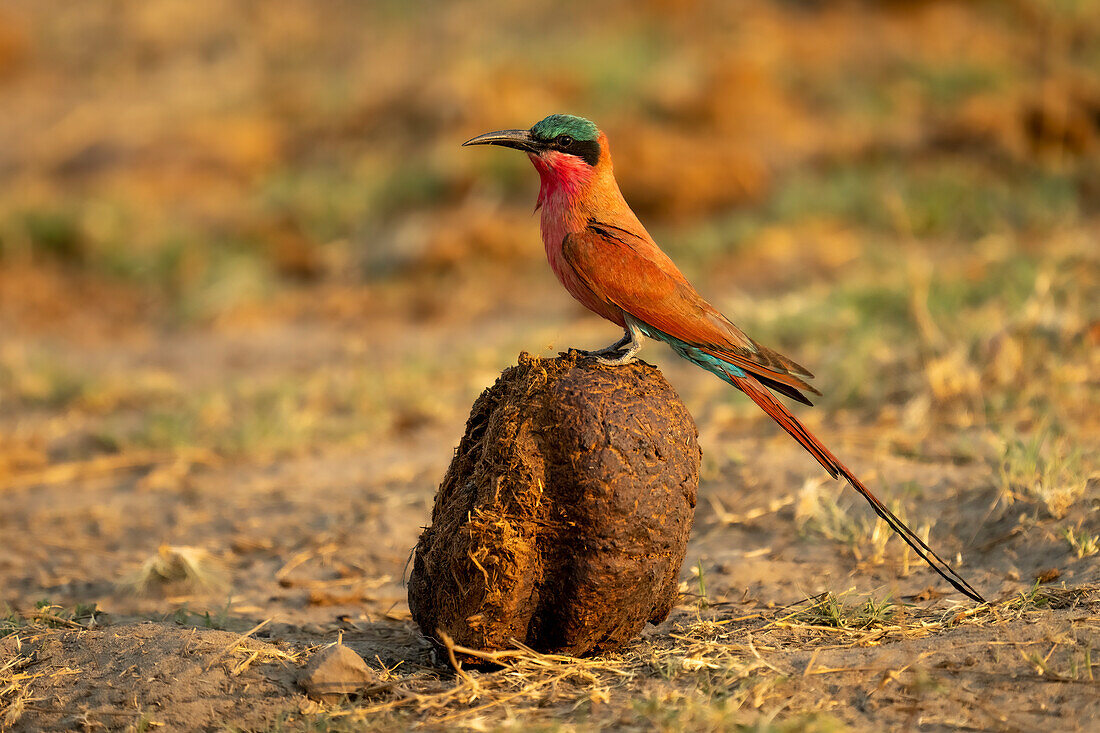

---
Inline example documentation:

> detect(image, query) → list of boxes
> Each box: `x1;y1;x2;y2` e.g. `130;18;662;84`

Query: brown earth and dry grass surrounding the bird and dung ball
0;0;1100;731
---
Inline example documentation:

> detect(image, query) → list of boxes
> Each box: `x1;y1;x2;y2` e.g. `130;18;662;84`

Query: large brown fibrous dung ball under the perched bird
409;352;700;655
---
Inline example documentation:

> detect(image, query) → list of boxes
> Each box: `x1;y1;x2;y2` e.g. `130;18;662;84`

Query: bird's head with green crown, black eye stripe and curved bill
462;114;611;195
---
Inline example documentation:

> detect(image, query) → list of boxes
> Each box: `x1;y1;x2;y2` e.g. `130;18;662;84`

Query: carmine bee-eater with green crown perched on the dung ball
463;114;983;602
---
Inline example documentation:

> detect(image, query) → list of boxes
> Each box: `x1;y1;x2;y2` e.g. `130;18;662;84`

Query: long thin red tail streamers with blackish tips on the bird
726;365;986;603
